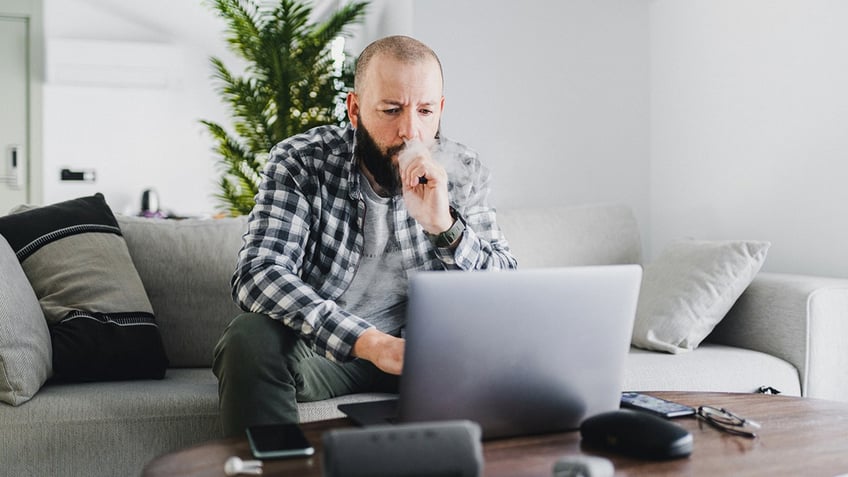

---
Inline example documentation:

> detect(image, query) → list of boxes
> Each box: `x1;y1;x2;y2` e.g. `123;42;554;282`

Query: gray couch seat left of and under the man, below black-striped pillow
0;368;388;477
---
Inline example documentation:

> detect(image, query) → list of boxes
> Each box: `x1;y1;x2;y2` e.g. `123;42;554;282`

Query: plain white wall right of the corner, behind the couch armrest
650;0;848;277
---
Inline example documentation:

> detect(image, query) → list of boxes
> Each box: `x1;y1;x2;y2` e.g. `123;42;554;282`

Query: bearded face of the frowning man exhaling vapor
347;54;444;193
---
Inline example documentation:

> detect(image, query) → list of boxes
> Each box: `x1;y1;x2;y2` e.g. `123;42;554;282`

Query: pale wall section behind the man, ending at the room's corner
413;0;650;236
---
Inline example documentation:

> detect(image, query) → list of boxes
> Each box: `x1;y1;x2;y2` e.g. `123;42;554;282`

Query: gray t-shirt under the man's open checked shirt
339;174;407;335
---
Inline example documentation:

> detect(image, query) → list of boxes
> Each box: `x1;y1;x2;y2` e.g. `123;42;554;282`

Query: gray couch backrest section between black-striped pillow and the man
118;216;247;367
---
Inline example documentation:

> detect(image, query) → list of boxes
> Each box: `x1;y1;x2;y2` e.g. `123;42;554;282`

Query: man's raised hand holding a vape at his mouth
398;142;453;235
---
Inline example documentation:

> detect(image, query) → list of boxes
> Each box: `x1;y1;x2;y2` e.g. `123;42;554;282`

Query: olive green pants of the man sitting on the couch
212;313;398;437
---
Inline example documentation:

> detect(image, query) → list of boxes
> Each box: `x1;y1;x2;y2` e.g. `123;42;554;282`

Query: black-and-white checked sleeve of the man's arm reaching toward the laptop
231;143;372;362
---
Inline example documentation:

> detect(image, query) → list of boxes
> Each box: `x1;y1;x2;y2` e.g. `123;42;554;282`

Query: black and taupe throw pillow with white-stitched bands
0;194;168;381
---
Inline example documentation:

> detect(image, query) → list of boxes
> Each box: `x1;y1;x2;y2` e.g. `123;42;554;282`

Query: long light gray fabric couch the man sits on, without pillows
0;205;848;477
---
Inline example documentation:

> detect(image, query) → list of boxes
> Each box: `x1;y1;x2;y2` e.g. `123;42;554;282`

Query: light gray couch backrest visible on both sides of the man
118;205;641;367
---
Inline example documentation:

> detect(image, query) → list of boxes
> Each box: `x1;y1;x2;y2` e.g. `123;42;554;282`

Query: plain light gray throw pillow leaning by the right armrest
632;240;770;353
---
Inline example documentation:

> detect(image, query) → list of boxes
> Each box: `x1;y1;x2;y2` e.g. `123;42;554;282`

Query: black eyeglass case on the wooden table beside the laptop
580;409;694;460
